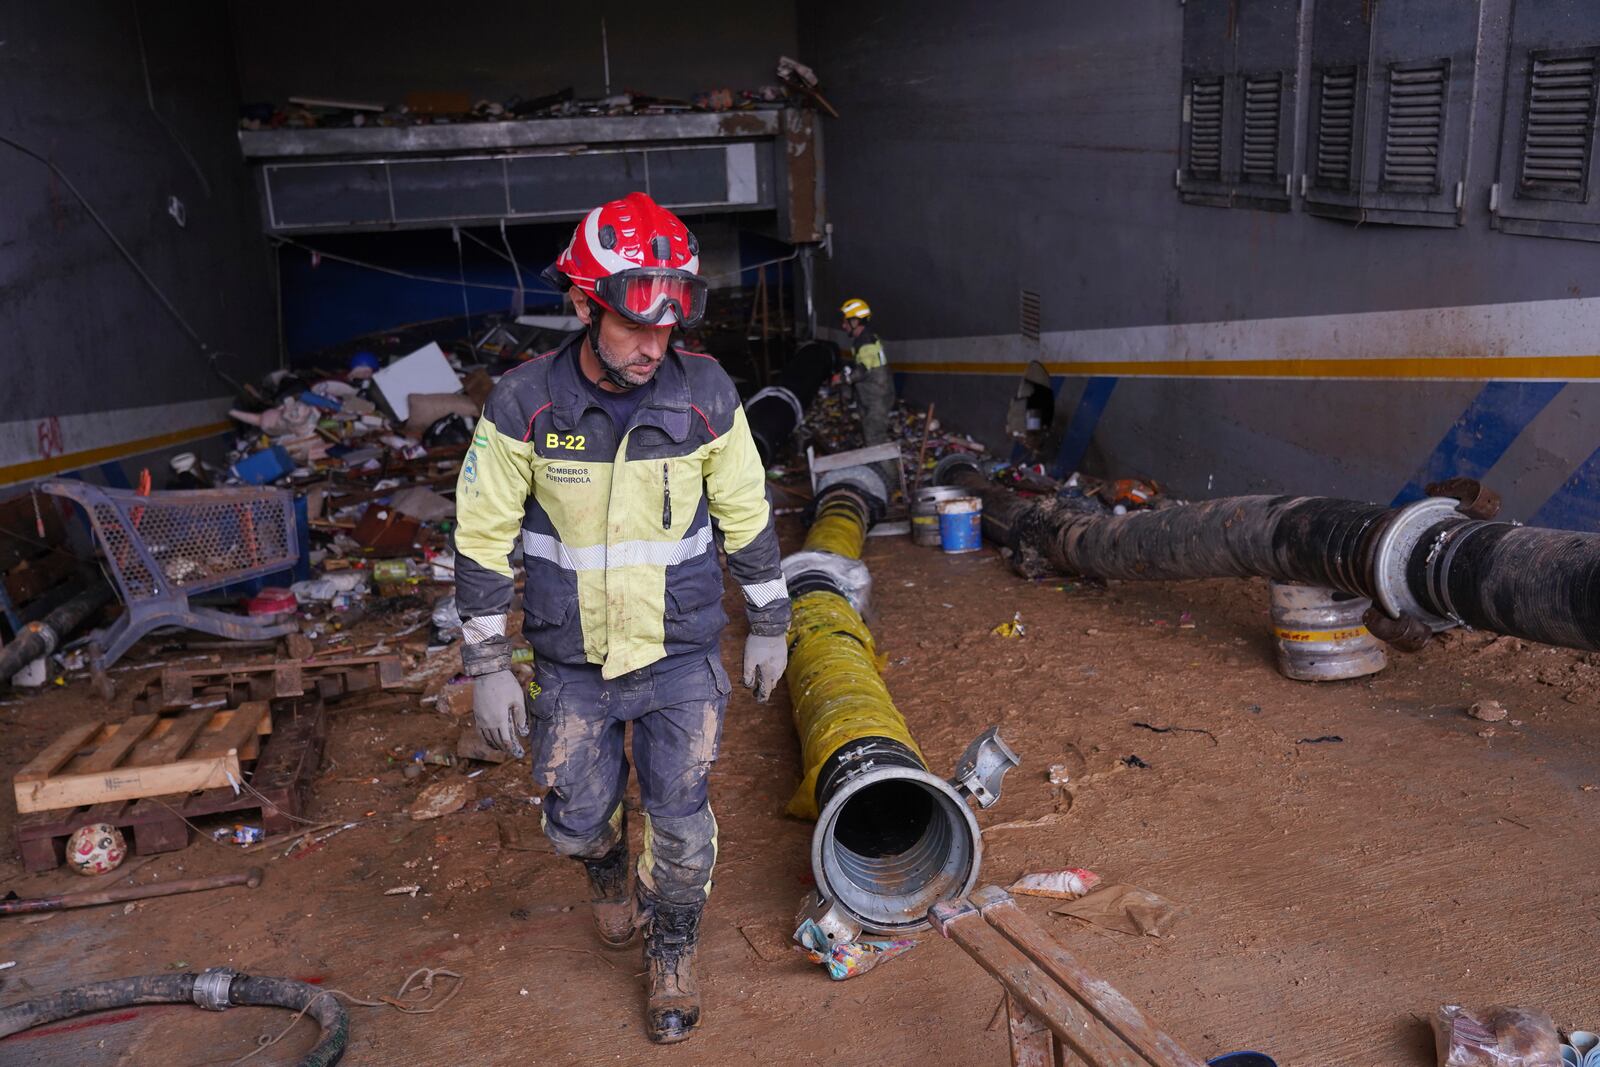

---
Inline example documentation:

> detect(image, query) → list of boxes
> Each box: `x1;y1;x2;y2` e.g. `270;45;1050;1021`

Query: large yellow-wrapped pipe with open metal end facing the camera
784;467;1018;939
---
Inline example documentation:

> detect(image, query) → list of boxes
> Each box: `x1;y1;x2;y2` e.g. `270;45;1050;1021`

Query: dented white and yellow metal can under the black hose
1272;582;1389;681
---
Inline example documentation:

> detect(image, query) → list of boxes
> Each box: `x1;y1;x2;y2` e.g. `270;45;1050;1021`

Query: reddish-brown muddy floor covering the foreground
0;530;1600;1067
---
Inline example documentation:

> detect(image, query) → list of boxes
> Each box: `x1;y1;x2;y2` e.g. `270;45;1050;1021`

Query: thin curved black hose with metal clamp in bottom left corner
0;968;350;1067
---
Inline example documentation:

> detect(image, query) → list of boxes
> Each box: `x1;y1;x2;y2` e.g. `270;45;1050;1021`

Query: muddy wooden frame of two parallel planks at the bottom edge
928;886;1205;1067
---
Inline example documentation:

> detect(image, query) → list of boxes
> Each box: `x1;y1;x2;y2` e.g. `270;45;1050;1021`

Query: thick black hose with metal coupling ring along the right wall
936;461;1600;649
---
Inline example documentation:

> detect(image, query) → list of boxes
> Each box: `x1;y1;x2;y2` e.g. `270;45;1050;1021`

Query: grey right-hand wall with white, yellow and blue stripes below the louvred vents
800;0;1600;526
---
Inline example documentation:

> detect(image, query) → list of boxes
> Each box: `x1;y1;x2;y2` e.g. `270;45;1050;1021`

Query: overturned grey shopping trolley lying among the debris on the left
38;480;299;673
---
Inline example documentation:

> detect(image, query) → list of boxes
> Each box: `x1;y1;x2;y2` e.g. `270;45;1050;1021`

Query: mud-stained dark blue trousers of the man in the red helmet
531;648;730;904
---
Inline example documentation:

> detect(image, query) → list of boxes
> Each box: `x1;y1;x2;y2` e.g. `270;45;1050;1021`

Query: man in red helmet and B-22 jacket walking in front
456;192;789;1041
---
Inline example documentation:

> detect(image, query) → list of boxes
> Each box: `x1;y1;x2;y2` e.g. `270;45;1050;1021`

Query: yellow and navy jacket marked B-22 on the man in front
456;334;789;678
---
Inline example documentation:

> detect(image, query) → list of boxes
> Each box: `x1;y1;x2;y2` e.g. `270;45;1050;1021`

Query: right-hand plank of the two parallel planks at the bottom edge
970;886;1205;1067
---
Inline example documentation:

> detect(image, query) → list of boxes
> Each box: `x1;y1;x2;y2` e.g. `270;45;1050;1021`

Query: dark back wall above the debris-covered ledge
230;0;795;104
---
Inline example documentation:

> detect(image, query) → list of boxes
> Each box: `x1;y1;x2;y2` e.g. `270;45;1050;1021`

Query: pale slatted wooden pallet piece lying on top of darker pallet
13;702;272;813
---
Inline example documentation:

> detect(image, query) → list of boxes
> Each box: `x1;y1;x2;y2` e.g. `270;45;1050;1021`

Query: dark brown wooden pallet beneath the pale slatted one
16;694;328;870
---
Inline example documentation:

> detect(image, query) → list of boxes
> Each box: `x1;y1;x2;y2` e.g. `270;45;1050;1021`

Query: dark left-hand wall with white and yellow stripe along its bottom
0;0;277;485
